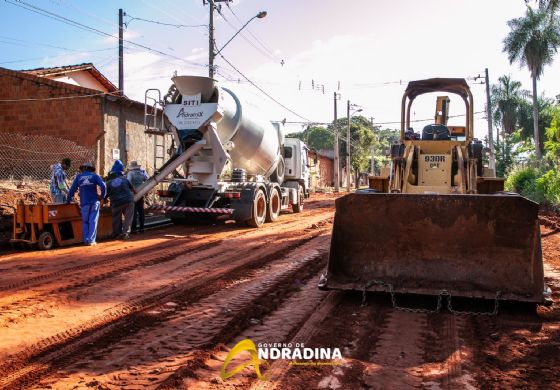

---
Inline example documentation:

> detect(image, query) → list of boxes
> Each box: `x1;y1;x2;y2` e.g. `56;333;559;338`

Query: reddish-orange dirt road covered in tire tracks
0;195;560;390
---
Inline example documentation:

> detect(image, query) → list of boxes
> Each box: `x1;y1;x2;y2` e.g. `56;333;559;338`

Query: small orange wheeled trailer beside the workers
10;202;112;250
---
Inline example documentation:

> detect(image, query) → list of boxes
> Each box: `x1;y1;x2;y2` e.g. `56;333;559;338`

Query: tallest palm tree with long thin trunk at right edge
503;7;560;160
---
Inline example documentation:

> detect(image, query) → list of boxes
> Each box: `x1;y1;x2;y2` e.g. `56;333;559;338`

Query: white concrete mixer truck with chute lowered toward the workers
136;76;309;227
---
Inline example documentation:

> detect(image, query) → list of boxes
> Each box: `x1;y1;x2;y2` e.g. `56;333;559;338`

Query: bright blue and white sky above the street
0;0;560;136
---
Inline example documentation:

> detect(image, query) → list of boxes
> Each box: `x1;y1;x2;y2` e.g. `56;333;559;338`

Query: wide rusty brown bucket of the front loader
320;192;544;303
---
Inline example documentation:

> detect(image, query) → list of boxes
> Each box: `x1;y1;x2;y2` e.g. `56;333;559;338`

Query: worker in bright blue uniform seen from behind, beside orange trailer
66;162;106;245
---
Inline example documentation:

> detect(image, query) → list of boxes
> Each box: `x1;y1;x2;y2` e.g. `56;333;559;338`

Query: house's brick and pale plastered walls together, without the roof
0;68;170;175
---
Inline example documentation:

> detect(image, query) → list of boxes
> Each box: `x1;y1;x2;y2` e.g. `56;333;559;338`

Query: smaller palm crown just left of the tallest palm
490;76;525;139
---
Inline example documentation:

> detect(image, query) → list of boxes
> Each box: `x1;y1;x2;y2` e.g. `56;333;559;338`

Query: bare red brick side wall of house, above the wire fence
0;68;103;148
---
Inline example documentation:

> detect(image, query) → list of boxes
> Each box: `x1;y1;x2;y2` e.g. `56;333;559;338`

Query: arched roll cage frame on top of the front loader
401;78;474;142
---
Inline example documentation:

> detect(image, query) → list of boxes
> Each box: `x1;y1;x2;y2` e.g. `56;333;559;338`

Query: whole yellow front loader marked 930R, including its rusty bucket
319;78;545;303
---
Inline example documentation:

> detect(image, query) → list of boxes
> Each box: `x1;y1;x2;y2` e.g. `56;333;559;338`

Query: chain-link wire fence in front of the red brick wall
0;133;95;180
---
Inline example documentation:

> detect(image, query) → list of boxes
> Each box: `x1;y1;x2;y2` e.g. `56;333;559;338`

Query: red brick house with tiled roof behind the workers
0;64;167;178
